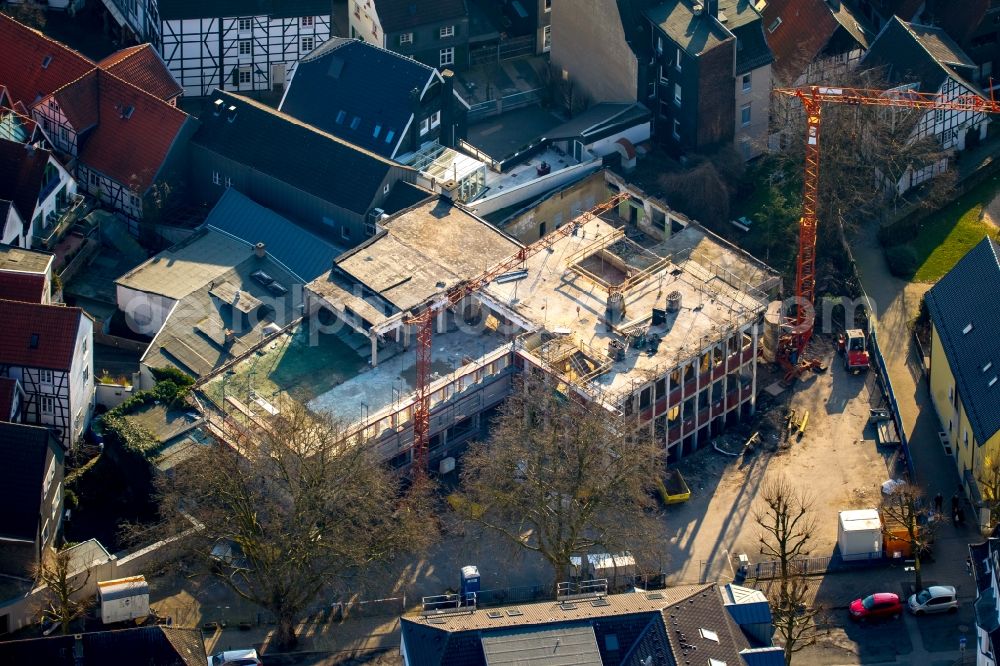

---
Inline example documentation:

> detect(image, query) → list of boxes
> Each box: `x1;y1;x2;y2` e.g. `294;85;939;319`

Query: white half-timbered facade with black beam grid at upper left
161;14;330;97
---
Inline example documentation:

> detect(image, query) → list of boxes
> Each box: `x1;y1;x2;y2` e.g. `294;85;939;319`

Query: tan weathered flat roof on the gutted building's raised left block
330;198;521;311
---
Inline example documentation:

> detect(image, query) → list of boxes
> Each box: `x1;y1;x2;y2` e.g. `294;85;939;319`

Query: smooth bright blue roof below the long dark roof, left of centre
205;188;343;282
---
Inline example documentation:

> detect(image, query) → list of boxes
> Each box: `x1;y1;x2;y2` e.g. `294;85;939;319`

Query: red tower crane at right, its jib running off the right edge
773;86;1000;371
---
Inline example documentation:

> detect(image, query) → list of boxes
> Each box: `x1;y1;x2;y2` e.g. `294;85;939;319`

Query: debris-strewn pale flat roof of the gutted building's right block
485;218;770;392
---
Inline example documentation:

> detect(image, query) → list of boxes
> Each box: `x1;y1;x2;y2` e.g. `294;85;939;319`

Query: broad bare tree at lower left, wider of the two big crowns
160;404;432;648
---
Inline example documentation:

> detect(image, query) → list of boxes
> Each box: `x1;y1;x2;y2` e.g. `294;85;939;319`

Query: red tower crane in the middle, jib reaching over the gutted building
404;191;629;475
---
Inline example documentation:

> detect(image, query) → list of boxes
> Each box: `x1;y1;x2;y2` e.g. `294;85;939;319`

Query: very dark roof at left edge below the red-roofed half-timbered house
0;422;60;540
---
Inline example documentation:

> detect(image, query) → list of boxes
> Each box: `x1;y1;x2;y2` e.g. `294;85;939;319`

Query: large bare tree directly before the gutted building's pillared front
456;374;662;587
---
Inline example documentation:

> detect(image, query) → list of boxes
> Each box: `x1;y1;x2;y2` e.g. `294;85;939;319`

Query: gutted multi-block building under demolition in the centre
201;183;780;467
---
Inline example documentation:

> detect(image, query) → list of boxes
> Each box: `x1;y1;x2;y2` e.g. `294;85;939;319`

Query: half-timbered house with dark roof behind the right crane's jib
860;17;989;194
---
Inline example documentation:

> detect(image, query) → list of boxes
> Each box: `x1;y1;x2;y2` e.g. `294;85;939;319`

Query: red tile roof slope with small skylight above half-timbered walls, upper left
79;71;189;193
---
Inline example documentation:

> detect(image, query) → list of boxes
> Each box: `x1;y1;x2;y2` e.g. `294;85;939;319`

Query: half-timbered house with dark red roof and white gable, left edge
0;300;94;450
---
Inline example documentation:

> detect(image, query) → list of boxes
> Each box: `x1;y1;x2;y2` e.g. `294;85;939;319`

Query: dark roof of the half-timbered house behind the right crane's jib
861;17;982;95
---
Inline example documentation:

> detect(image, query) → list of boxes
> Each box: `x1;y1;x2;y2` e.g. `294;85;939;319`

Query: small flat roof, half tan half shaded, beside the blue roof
115;228;253;300
